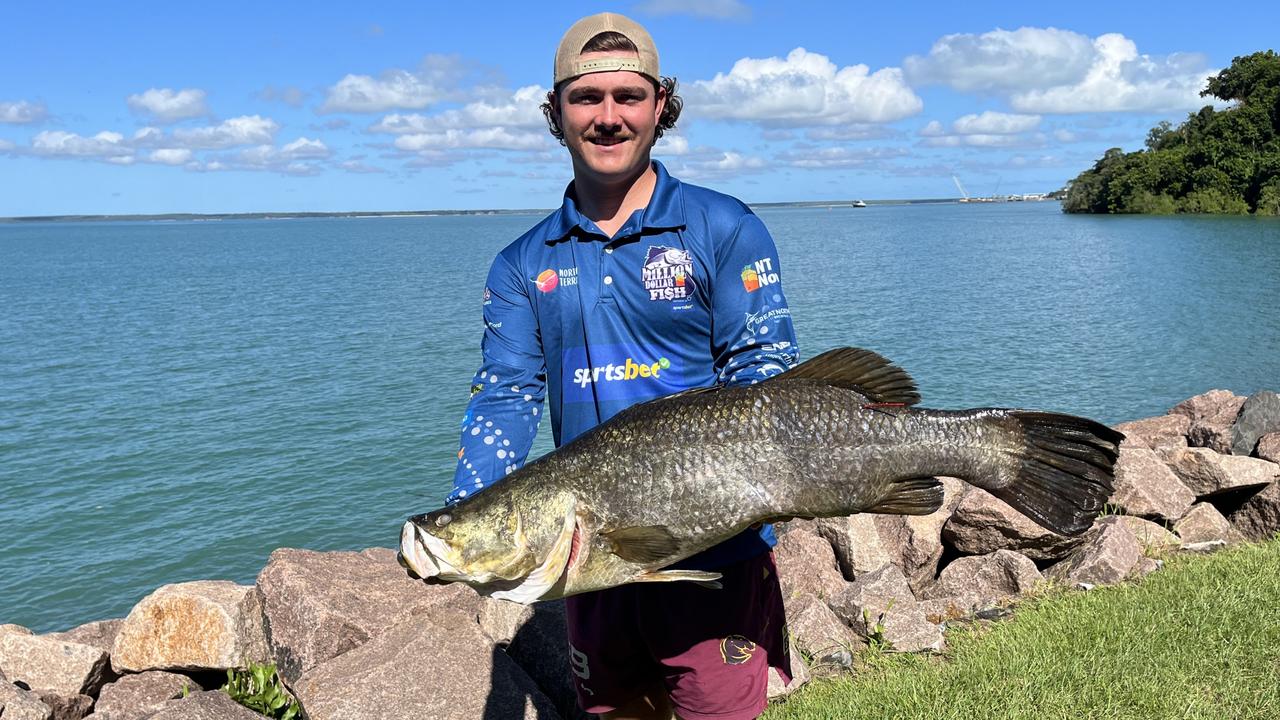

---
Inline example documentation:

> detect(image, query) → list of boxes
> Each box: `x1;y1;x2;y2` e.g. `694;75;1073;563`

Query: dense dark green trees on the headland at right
1062;50;1280;215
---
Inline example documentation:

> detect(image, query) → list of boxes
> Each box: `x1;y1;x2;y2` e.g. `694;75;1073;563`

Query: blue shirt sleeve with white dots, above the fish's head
445;255;547;505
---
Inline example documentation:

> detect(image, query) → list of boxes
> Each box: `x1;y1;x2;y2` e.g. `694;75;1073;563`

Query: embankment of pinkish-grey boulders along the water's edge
0;391;1280;720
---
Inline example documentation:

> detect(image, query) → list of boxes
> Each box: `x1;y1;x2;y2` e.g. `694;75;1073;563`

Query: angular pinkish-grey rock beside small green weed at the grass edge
831;565;943;652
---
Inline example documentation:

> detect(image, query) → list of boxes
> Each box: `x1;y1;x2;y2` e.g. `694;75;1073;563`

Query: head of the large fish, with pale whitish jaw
399;483;576;602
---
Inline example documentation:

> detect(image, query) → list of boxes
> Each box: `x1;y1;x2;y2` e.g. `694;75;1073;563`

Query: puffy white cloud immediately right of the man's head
686;47;924;127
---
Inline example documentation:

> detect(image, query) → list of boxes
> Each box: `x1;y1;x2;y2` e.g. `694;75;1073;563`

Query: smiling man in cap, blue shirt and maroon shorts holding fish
449;13;797;720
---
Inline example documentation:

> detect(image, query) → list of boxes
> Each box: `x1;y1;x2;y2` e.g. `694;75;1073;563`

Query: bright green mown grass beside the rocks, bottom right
764;538;1280;720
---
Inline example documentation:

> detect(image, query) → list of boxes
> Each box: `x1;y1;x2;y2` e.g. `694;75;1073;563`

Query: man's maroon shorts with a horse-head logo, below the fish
566;552;790;720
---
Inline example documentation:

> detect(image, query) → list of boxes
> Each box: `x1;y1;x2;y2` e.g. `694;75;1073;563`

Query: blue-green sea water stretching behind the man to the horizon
0;202;1280;632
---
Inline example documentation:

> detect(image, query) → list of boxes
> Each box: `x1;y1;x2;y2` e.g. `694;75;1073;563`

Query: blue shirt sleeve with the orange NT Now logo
712;213;799;384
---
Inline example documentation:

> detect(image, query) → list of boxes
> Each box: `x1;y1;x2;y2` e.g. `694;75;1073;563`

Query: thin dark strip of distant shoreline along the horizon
0;197;998;223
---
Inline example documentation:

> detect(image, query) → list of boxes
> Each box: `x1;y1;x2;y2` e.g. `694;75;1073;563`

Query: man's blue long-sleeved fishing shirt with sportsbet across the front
447;161;799;570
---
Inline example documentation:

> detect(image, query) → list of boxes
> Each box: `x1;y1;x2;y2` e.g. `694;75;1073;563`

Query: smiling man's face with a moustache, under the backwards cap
552;53;667;183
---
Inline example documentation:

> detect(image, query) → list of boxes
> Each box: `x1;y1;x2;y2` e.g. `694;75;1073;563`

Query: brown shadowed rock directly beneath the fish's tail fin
942;484;1080;560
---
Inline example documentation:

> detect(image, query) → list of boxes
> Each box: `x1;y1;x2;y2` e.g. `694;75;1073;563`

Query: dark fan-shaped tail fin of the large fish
984;410;1124;536
